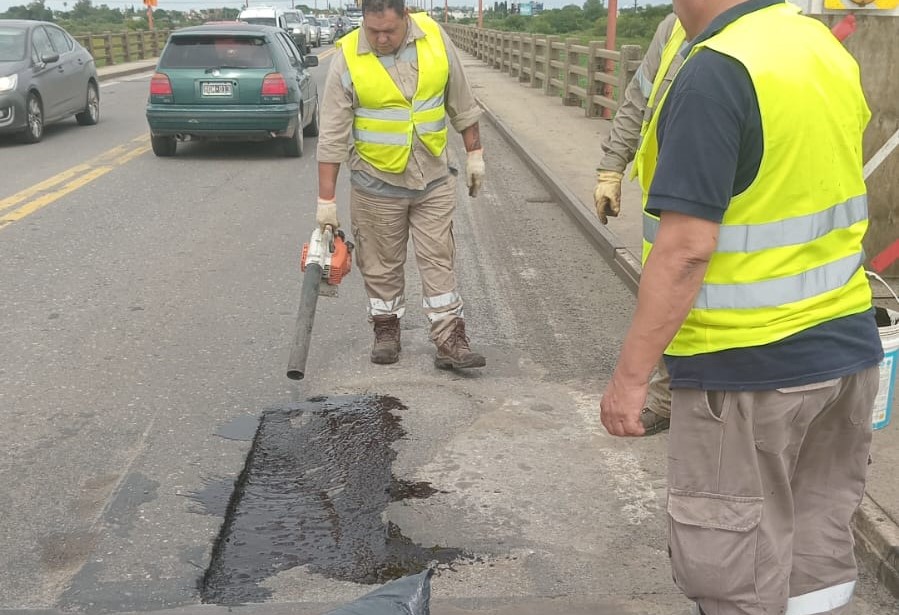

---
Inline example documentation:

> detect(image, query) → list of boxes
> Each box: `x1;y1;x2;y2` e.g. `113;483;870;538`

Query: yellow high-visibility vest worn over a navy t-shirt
637;3;871;356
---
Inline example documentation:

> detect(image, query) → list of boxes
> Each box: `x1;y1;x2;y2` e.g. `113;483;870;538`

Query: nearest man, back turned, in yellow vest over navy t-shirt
600;0;883;615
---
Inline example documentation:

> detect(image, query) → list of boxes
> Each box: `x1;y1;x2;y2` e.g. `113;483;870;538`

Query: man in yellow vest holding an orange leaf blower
316;0;486;369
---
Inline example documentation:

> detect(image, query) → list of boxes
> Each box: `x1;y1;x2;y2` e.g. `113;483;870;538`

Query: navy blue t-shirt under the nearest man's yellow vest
646;0;883;390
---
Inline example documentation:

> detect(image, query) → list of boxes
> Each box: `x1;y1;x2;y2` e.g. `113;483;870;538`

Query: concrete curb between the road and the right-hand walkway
478;99;899;598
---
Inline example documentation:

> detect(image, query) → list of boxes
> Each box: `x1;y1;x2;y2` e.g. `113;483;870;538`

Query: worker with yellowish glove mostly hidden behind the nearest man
593;13;686;436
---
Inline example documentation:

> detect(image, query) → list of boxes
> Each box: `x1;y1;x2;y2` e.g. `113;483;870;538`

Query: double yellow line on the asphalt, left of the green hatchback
0;134;150;229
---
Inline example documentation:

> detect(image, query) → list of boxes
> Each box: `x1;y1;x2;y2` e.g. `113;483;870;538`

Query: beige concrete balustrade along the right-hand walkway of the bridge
443;24;643;118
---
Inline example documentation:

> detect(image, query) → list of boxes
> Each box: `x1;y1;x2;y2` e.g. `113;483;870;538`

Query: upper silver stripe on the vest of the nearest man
643;195;868;253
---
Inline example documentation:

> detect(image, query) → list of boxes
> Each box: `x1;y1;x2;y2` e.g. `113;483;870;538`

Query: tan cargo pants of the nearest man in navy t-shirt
668;367;878;615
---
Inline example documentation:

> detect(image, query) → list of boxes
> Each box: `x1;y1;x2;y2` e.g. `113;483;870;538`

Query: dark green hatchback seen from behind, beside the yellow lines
147;23;319;156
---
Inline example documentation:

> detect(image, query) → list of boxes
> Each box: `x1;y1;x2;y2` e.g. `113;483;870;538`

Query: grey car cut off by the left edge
0;19;100;143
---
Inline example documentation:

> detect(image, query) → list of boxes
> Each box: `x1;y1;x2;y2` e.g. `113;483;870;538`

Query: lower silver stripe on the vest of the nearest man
693;252;865;310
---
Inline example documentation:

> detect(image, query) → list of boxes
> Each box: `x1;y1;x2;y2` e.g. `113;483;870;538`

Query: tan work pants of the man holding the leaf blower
350;176;463;345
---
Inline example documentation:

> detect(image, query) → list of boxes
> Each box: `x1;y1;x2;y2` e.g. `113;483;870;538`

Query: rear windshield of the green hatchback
159;35;274;68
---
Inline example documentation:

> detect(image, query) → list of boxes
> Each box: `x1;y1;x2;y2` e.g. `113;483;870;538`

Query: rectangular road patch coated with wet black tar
194;395;466;604
